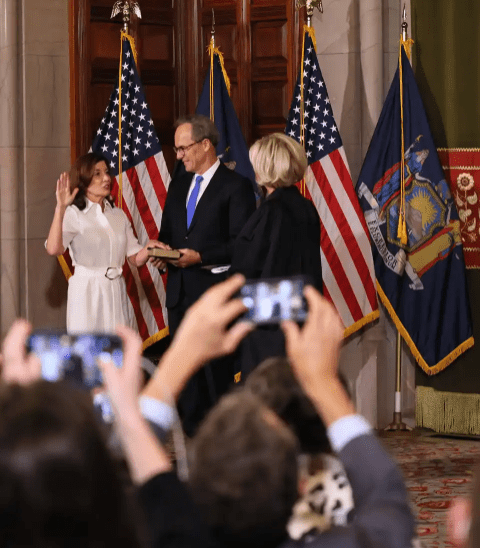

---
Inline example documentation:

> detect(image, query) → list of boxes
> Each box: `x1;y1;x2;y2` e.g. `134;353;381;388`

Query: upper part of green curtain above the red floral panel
412;0;480;148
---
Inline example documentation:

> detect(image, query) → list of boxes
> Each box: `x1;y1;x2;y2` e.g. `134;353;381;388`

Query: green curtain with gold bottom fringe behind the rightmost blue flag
412;0;480;434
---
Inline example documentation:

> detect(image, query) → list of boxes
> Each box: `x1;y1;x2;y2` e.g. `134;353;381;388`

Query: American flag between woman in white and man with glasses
92;34;170;347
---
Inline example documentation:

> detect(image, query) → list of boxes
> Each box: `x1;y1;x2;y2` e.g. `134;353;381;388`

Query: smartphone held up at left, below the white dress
27;330;123;390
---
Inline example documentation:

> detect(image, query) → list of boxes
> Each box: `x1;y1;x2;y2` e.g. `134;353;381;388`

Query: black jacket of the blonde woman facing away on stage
231;186;322;291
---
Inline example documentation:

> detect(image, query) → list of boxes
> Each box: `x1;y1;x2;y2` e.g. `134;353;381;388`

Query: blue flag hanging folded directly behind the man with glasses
196;44;258;195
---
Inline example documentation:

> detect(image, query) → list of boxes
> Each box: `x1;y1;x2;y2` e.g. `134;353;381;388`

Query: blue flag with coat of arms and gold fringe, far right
356;46;474;375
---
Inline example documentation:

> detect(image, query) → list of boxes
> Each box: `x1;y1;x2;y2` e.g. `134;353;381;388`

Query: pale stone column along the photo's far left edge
0;0;19;338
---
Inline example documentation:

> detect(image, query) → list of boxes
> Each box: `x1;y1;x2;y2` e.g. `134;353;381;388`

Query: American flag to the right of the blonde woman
285;29;379;336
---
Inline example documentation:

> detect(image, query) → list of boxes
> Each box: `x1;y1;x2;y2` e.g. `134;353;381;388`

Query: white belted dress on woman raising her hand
63;199;142;333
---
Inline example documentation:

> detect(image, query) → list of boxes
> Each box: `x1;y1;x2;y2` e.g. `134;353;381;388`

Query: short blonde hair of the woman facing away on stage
250;133;308;187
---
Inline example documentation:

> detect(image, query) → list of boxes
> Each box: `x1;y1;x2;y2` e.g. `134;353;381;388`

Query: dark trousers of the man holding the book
168;297;234;437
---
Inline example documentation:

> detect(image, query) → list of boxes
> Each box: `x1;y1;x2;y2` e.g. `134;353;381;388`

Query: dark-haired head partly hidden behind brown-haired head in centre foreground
245;356;331;454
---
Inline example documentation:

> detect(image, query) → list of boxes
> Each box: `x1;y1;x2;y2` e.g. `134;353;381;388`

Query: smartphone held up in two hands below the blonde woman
237;276;310;325
